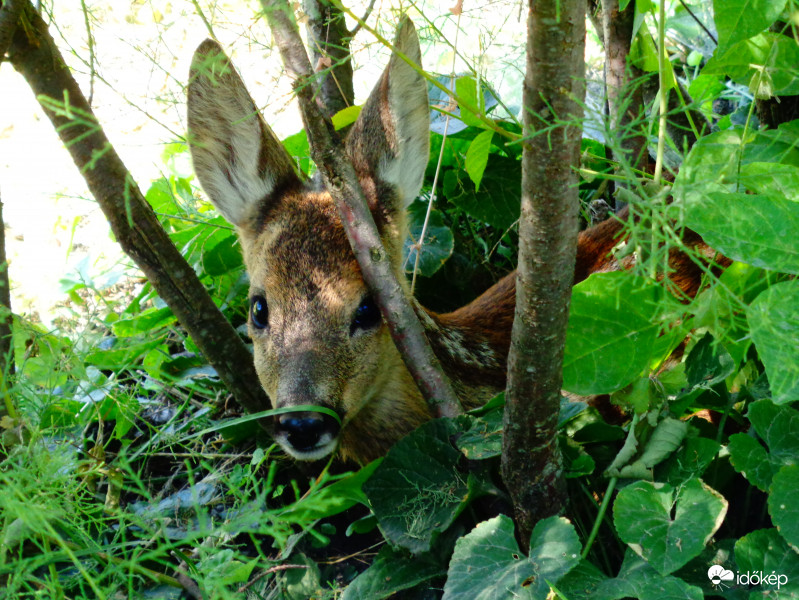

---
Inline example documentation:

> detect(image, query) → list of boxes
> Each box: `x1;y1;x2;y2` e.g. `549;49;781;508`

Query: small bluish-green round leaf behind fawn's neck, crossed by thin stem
402;200;455;277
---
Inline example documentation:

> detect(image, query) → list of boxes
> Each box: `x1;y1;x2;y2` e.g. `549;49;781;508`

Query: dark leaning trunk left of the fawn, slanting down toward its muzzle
8;2;269;418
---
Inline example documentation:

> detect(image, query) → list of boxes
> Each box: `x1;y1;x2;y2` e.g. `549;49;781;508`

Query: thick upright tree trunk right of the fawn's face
502;0;586;546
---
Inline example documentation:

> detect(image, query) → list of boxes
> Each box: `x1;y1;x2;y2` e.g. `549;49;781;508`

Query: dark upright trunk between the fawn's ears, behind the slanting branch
302;0;355;117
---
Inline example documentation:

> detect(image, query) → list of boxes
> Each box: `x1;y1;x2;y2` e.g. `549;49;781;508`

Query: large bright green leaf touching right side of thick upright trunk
563;272;660;396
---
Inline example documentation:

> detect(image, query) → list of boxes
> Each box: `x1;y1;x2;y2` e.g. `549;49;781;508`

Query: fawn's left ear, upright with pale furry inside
188;40;299;227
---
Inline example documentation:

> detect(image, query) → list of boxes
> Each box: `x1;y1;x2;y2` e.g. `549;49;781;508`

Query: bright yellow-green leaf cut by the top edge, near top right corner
713;0;786;50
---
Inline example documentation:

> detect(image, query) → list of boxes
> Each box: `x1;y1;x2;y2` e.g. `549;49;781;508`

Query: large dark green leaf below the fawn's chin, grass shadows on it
363;419;468;554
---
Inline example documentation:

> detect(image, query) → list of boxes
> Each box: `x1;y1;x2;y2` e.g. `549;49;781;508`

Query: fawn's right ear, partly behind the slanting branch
347;17;430;210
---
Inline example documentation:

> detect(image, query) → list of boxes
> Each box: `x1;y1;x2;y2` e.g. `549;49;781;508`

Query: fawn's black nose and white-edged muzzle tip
275;411;341;460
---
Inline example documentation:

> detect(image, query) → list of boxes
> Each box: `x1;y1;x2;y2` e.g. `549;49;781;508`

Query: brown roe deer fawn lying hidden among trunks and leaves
188;18;720;462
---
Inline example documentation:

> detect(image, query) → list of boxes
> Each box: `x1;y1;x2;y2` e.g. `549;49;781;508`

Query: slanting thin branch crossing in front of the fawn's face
261;0;462;417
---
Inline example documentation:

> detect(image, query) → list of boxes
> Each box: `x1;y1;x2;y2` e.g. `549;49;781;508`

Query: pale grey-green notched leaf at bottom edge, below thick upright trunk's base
444;515;580;600
